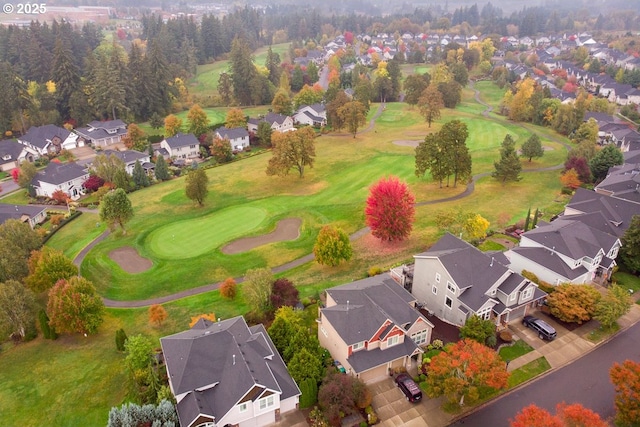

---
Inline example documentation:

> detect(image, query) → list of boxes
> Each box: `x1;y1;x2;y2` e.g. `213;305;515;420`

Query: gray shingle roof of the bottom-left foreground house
160;316;300;425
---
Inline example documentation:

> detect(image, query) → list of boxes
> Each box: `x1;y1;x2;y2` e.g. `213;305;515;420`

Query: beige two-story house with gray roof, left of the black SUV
405;233;546;326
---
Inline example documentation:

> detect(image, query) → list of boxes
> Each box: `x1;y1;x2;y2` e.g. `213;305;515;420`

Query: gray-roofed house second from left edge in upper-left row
18;125;83;158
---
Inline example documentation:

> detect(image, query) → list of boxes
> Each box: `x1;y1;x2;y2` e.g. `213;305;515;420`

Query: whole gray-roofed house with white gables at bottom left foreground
160;316;301;427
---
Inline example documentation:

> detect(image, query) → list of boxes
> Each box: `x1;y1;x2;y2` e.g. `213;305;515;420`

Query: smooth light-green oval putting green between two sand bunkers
146;206;267;259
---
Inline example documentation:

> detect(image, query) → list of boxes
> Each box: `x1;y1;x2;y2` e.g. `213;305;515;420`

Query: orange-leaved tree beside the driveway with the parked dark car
427;339;509;406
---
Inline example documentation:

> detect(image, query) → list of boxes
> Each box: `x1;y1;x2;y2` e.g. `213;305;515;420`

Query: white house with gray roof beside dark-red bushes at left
31;162;89;200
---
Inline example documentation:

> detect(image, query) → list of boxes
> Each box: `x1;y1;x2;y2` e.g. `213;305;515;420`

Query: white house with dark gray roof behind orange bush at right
505;212;621;285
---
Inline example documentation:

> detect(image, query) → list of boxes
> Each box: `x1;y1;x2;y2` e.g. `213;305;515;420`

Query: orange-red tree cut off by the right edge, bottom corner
609;360;640;426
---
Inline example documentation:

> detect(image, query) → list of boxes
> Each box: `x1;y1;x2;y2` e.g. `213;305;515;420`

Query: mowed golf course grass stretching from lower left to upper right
0;81;564;426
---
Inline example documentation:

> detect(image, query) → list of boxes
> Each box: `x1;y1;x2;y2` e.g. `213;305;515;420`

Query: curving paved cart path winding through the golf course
73;88;570;308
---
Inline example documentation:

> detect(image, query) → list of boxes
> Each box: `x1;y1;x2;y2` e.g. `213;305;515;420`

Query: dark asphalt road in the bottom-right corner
451;323;640;427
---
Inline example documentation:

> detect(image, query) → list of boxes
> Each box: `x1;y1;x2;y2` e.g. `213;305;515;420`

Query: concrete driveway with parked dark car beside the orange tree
369;378;453;427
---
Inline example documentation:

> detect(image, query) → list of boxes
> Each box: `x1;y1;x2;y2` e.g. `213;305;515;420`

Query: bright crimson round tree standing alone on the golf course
364;176;415;241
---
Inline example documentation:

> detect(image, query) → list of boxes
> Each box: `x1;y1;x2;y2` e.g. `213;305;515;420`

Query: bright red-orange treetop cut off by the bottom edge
510;402;608;427
